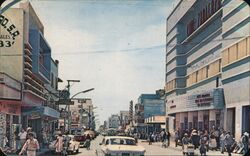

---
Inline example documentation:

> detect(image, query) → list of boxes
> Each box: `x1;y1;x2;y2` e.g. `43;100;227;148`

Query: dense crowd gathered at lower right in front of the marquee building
174;127;249;156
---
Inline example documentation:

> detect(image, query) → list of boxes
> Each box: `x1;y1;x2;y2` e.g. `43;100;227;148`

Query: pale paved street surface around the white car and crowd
68;136;240;156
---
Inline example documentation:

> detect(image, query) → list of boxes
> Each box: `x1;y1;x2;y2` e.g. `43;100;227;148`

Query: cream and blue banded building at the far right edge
221;0;250;138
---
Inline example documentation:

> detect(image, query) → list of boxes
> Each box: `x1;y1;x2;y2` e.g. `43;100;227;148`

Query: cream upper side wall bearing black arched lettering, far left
0;8;24;81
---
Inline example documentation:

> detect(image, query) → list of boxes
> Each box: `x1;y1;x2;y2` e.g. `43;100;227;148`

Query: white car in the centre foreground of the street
100;136;146;156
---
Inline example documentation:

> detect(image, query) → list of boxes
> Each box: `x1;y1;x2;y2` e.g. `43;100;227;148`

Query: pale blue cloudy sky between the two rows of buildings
24;0;179;123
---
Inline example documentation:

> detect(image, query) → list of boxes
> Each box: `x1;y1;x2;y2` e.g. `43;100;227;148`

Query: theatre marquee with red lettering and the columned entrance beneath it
167;88;224;131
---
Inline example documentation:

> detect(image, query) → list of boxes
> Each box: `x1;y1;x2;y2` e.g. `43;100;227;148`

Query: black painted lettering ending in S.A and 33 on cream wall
0;15;20;47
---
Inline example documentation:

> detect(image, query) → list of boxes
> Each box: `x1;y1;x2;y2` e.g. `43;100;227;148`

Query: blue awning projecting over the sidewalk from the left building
21;106;60;119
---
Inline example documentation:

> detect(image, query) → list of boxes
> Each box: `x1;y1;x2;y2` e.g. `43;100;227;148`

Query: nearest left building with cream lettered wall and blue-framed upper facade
0;2;59;147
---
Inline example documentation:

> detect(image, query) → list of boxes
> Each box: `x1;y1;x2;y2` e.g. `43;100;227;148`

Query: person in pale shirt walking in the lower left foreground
19;133;39;156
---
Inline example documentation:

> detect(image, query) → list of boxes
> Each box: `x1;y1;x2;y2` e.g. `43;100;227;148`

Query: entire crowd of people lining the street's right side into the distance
129;126;249;156
